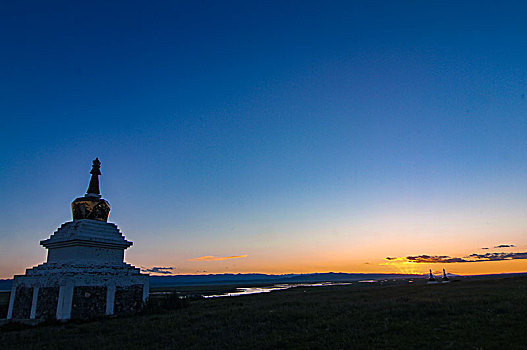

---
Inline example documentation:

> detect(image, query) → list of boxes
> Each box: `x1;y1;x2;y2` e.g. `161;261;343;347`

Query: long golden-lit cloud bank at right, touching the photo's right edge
385;252;527;264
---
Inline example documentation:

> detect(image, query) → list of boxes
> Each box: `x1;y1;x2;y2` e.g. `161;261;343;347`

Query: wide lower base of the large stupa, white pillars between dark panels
7;263;149;320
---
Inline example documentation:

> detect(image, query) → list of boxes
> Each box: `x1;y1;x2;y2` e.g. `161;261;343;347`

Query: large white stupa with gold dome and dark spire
7;158;149;320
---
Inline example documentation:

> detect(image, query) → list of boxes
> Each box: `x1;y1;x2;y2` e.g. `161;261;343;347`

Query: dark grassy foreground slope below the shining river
0;277;527;349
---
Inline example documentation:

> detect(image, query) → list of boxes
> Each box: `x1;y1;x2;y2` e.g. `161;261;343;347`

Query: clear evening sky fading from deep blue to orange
0;1;527;277
